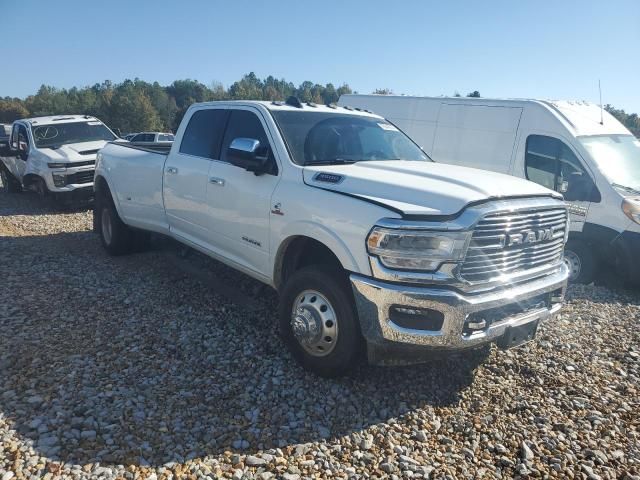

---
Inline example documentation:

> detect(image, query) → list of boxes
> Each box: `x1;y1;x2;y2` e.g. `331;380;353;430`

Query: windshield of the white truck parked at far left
33;121;116;148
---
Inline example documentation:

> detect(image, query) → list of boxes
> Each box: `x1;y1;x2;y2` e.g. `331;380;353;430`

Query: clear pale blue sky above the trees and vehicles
5;0;640;113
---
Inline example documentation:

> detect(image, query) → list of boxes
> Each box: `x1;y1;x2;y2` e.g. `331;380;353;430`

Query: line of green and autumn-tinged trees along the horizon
0;72;640;137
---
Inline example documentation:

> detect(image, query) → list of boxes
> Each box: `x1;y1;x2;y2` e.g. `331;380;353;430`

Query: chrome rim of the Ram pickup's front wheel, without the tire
291;290;338;357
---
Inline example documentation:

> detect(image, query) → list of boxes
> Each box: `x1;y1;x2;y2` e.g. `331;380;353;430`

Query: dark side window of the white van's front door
525;135;599;201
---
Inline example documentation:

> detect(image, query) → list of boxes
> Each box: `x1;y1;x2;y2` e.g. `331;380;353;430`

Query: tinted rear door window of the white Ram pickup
180;109;227;159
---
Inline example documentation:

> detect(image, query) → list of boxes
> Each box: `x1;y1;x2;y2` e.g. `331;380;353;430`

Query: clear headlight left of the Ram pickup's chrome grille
367;227;470;271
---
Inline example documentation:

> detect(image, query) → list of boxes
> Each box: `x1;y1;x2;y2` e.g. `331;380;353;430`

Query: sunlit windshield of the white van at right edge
578;135;640;191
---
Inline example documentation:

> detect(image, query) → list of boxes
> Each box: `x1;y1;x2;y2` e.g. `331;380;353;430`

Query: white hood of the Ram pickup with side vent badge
303;161;562;215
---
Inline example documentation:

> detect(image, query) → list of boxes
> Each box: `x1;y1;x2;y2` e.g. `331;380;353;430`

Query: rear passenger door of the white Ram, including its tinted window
163;107;227;249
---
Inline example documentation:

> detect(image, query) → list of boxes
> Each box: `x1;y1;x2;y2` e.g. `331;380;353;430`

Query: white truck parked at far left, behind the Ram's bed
0;115;118;203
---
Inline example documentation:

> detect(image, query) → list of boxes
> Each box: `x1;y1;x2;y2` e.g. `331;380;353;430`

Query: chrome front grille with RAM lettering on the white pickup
460;208;567;283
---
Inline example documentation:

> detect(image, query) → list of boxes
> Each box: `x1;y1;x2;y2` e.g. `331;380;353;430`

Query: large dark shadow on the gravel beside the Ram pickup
0;232;496;465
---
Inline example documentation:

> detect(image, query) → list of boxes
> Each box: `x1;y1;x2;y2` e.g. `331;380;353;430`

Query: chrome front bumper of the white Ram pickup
350;264;568;364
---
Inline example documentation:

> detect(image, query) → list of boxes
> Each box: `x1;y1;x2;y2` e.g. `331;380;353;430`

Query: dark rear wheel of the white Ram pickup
94;193;136;255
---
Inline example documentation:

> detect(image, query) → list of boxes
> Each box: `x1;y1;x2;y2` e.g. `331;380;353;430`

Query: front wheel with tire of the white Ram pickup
279;266;362;377
